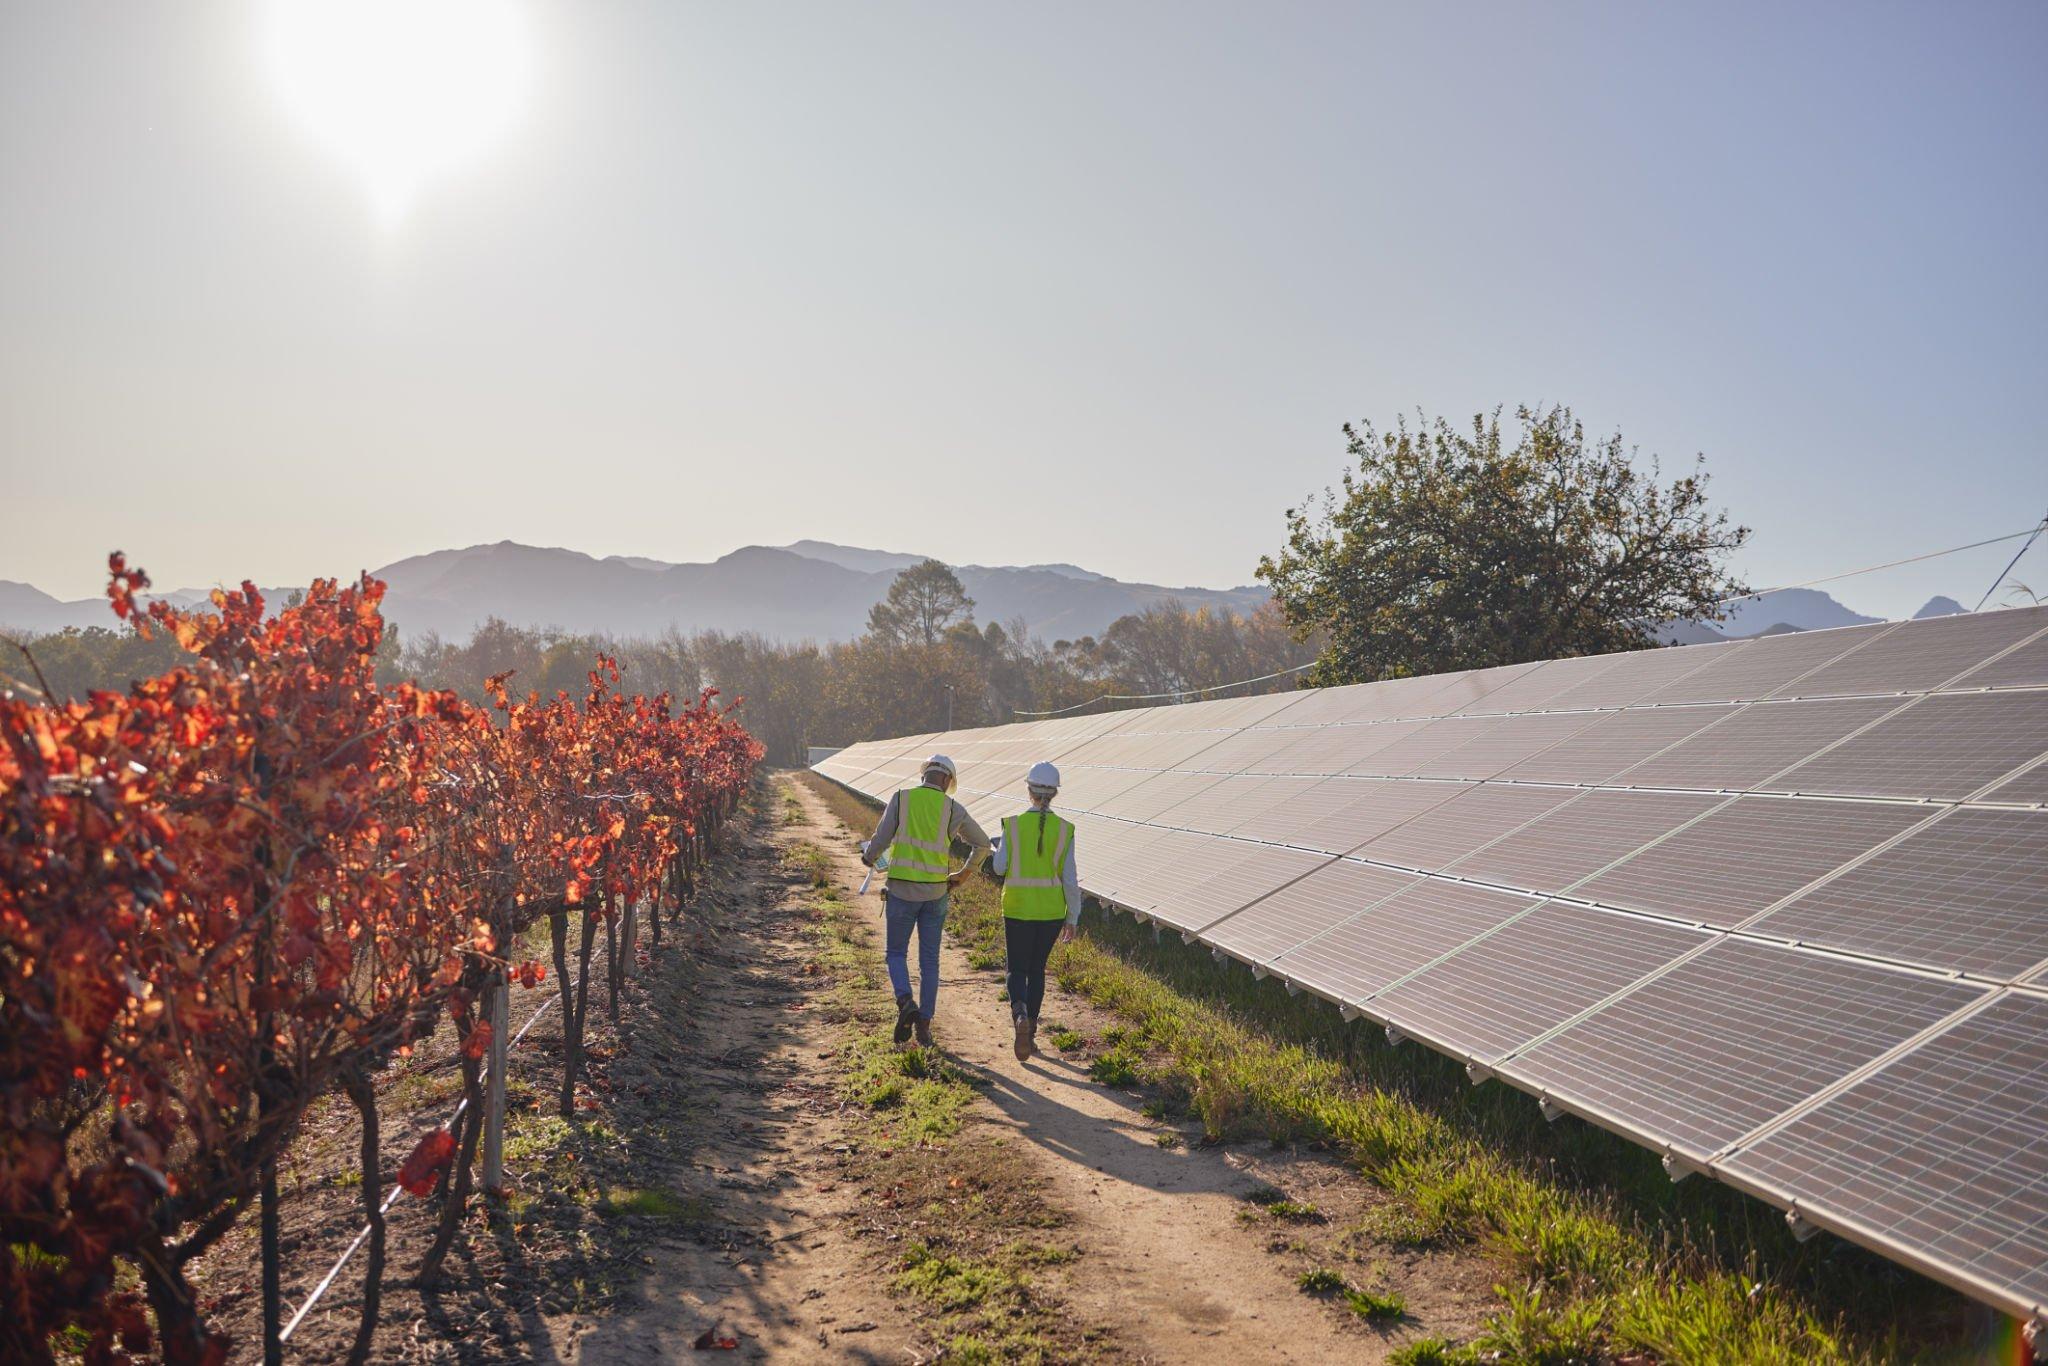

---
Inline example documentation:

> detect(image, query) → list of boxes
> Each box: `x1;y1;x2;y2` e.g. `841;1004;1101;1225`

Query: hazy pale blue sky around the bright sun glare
0;2;2048;612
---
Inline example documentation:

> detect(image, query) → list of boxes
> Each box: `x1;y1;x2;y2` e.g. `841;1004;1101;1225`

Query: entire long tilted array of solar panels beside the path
817;608;2048;1319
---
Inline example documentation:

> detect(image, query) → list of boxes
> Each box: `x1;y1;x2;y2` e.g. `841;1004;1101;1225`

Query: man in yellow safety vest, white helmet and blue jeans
860;754;989;1049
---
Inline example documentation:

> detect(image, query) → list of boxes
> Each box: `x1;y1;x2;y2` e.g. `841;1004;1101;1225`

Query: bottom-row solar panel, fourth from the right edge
1272;874;1536;1001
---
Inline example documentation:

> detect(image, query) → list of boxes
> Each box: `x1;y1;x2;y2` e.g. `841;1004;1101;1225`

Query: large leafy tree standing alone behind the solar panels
1260;408;1749;686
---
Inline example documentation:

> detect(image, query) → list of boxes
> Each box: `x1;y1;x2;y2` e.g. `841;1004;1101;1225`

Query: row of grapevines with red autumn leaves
0;555;760;1362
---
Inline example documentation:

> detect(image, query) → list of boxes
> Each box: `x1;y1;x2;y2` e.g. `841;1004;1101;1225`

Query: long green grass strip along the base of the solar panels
790;778;1968;1364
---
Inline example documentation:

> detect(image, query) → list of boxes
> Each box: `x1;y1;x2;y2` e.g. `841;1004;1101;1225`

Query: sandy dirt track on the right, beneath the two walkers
791;784;1491;1362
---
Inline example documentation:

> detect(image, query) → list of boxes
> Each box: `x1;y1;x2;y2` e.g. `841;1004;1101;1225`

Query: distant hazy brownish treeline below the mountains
0;561;1317;764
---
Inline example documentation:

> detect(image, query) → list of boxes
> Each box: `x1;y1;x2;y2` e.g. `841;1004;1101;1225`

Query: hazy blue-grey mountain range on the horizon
0;541;1962;643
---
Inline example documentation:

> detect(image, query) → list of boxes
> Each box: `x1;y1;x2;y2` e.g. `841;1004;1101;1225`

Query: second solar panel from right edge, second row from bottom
1573;797;1927;928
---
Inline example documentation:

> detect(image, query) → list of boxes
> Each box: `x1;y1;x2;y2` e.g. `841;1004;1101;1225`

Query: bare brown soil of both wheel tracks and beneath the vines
201;776;1495;1362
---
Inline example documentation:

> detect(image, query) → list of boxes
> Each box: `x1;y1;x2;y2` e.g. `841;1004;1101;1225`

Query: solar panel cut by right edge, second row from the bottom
1751;807;2048;979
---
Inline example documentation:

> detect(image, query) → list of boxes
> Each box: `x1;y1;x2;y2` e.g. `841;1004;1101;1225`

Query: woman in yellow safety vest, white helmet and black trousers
995;764;1081;1063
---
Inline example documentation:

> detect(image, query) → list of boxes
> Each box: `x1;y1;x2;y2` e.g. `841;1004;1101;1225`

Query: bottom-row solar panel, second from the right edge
1507;940;1980;1159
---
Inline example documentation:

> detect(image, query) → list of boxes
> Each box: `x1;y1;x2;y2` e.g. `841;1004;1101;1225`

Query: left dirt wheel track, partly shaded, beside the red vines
553;806;911;1362
